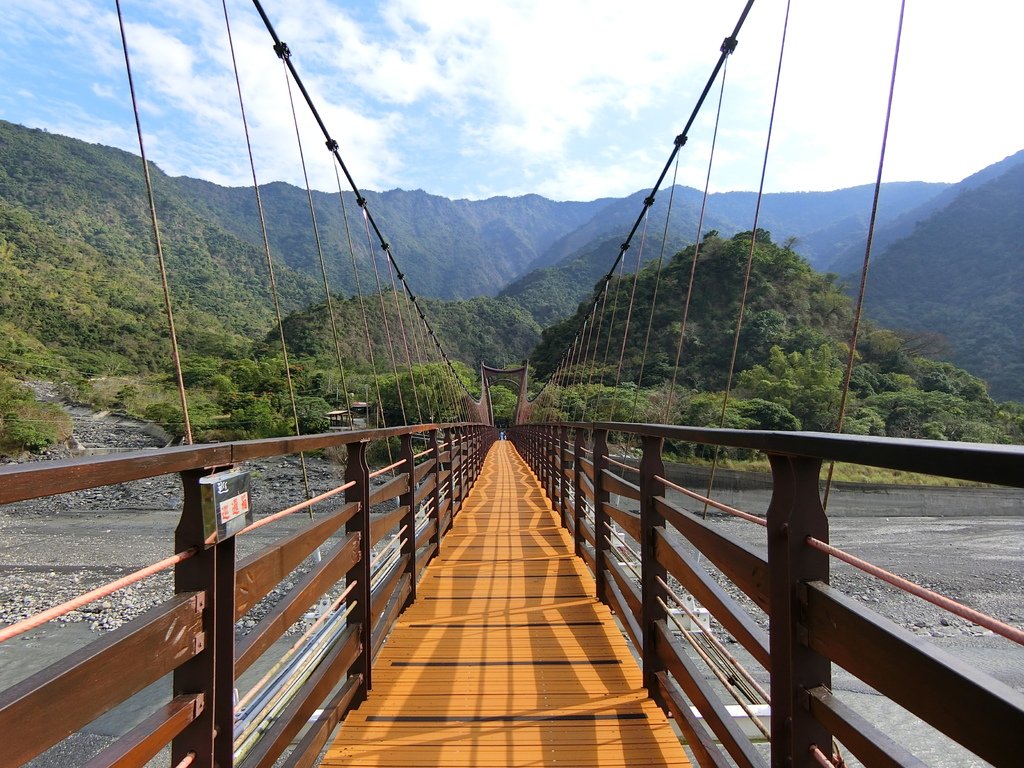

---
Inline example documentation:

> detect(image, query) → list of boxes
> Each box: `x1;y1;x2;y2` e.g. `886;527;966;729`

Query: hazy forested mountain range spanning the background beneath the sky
0;121;1024;400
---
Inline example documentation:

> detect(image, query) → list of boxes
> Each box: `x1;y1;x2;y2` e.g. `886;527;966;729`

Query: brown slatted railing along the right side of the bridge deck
509;423;1024;766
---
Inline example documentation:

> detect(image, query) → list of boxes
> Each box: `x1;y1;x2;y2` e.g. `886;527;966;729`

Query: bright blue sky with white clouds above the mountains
0;0;1024;200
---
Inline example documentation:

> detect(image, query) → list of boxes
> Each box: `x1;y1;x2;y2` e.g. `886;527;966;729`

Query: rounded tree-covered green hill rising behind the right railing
531;230;1024;442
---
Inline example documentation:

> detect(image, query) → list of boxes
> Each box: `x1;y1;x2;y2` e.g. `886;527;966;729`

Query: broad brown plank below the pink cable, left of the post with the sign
0;592;205;765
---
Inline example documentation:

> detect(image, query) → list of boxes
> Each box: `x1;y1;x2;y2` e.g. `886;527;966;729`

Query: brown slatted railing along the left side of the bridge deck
0;424;497;768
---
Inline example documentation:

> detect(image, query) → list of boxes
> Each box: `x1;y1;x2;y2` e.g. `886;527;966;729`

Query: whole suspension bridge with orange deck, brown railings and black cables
0;2;1024;768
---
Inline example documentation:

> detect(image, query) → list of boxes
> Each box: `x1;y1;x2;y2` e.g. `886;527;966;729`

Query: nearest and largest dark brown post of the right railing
767;454;831;768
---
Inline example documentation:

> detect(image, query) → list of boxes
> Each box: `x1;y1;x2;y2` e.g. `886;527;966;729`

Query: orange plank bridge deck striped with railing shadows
322;442;688;768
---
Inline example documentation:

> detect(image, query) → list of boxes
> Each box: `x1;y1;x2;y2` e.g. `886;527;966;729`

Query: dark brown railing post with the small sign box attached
171;469;234;768
